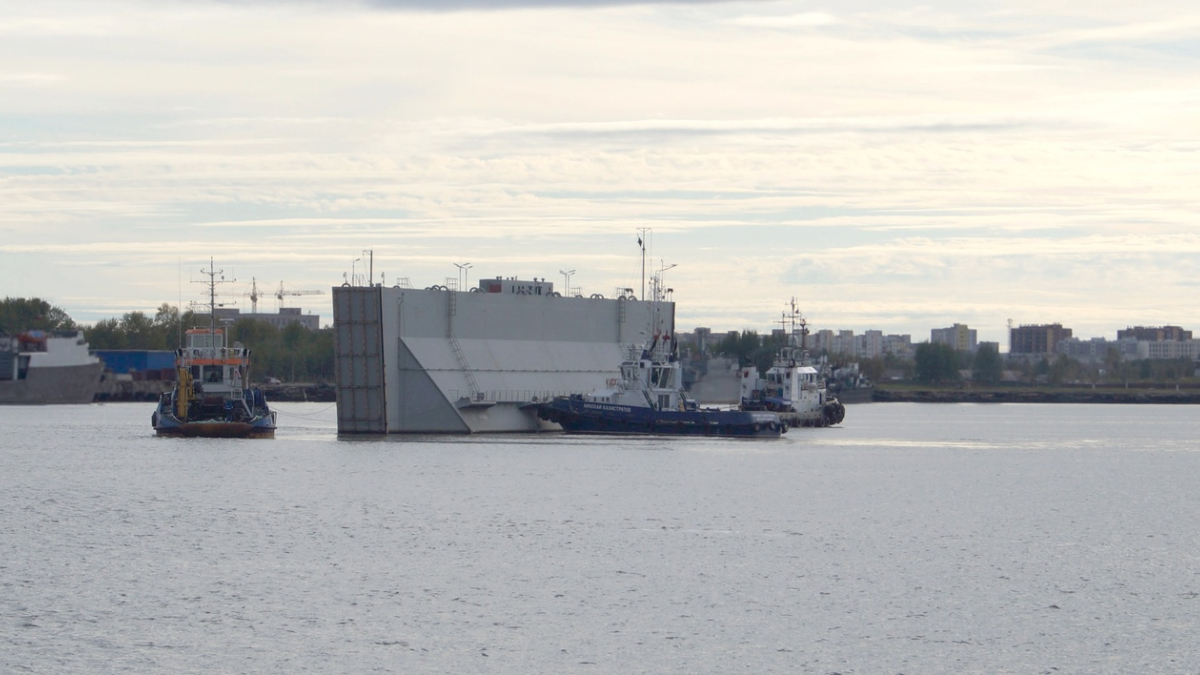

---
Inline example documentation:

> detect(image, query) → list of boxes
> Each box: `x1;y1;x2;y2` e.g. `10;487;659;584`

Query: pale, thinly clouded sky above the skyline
0;0;1200;350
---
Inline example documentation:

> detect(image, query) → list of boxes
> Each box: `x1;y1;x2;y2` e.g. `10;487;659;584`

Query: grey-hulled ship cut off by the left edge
0;330;104;405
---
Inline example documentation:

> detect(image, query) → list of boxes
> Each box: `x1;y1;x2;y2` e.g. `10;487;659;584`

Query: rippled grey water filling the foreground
0;404;1200;674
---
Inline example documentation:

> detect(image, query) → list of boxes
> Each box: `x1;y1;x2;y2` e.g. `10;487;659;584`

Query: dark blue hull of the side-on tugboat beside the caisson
538;399;786;438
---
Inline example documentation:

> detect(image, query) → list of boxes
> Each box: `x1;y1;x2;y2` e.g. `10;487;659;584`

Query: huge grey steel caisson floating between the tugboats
334;279;674;434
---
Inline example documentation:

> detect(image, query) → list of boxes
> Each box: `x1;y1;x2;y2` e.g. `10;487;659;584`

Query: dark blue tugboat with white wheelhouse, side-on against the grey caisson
538;338;787;438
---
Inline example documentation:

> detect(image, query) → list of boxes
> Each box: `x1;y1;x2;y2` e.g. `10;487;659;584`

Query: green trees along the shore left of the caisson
0;298;334;382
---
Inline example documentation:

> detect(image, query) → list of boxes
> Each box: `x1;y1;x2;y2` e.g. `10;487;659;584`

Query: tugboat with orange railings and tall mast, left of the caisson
150;257;275;438
